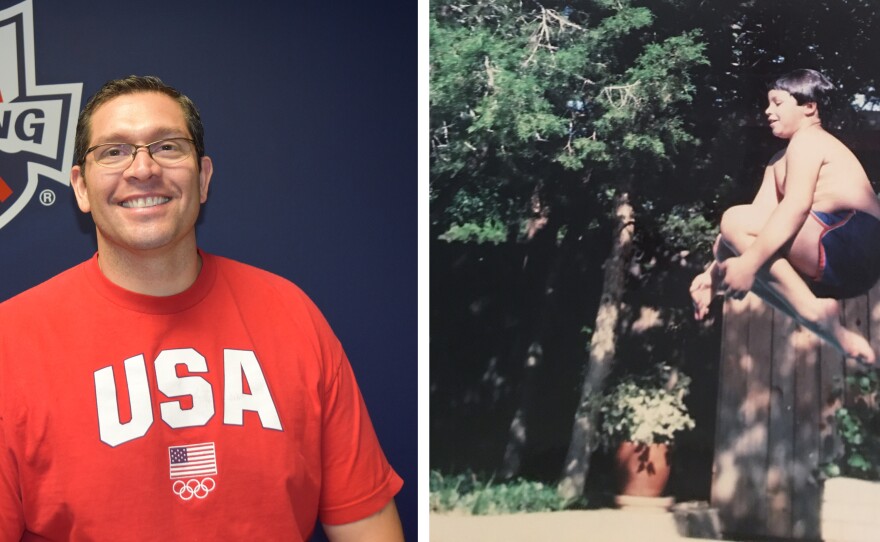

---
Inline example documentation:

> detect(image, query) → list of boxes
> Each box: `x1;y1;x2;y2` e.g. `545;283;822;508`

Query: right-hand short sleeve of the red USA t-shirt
319;346;403;525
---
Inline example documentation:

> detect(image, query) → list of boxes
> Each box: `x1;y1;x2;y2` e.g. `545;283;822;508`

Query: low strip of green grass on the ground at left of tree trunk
430;471;572;515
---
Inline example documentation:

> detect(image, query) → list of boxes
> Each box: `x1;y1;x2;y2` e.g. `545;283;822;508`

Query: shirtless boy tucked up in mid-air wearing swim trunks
690;70;880;363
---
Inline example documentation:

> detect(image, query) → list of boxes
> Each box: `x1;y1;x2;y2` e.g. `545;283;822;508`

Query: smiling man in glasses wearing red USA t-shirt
0;76;403;541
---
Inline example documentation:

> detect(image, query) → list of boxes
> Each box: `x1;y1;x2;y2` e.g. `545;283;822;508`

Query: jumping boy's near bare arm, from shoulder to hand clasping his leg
724;133;824;292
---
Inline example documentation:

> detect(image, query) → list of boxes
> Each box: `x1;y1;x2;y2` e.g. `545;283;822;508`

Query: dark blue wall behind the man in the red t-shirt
0;0;417;540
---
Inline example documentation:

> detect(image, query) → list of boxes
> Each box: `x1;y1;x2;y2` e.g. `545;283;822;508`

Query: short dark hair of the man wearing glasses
73;75;205;170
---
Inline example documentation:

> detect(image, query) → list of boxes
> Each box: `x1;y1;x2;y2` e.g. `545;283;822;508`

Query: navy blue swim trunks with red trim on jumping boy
807;211;880;299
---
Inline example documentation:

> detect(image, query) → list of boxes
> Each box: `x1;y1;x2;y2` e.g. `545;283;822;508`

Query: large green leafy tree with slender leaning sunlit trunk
430;0;706;497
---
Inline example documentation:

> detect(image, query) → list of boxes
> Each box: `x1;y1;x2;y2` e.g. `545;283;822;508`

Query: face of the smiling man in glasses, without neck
70;92;212;253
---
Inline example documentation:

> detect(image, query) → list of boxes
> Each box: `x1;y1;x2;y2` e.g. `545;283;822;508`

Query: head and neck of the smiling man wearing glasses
70;88;213;296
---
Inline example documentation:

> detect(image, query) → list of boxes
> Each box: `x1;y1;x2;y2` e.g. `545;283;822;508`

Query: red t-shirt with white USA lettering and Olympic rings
0;253;403;541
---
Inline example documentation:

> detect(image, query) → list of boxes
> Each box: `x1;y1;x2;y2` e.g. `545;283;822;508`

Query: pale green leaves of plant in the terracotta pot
599;363;694;446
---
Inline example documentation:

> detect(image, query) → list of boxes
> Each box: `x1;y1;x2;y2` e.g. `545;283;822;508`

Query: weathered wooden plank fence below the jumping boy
712;284;880;540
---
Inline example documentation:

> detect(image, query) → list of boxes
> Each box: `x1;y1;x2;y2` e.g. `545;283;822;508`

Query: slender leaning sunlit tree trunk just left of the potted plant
557;191;634;498
